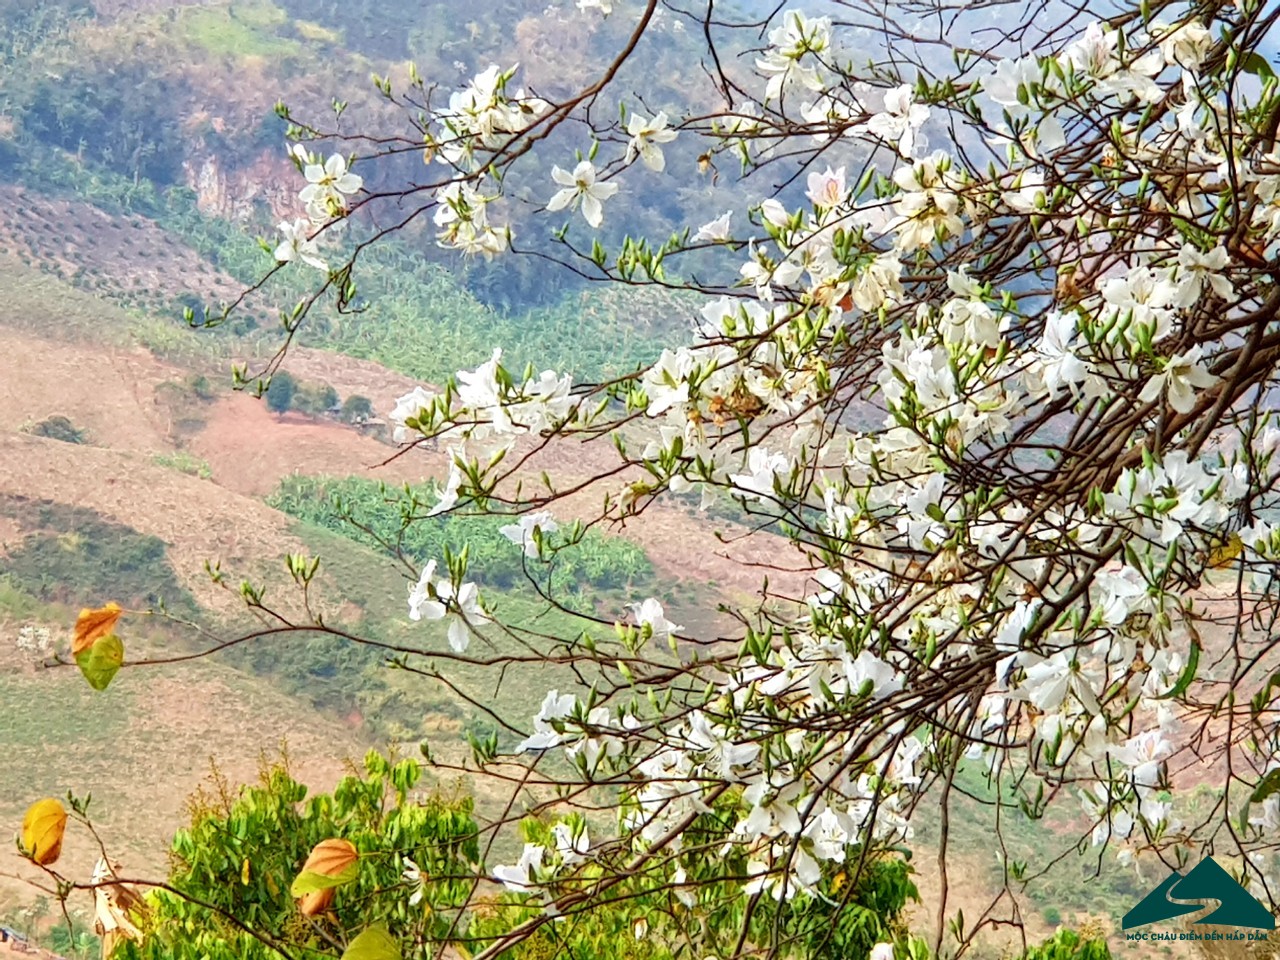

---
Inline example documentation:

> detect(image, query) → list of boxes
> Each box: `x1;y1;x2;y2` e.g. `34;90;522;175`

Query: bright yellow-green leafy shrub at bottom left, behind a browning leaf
115;753;480;960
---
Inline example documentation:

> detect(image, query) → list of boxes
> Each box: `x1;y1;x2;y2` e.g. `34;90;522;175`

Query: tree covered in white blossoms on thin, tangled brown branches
22;0;1280;960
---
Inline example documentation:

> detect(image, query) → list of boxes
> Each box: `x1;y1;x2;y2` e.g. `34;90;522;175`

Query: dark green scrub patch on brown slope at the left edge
0;495;196;613
